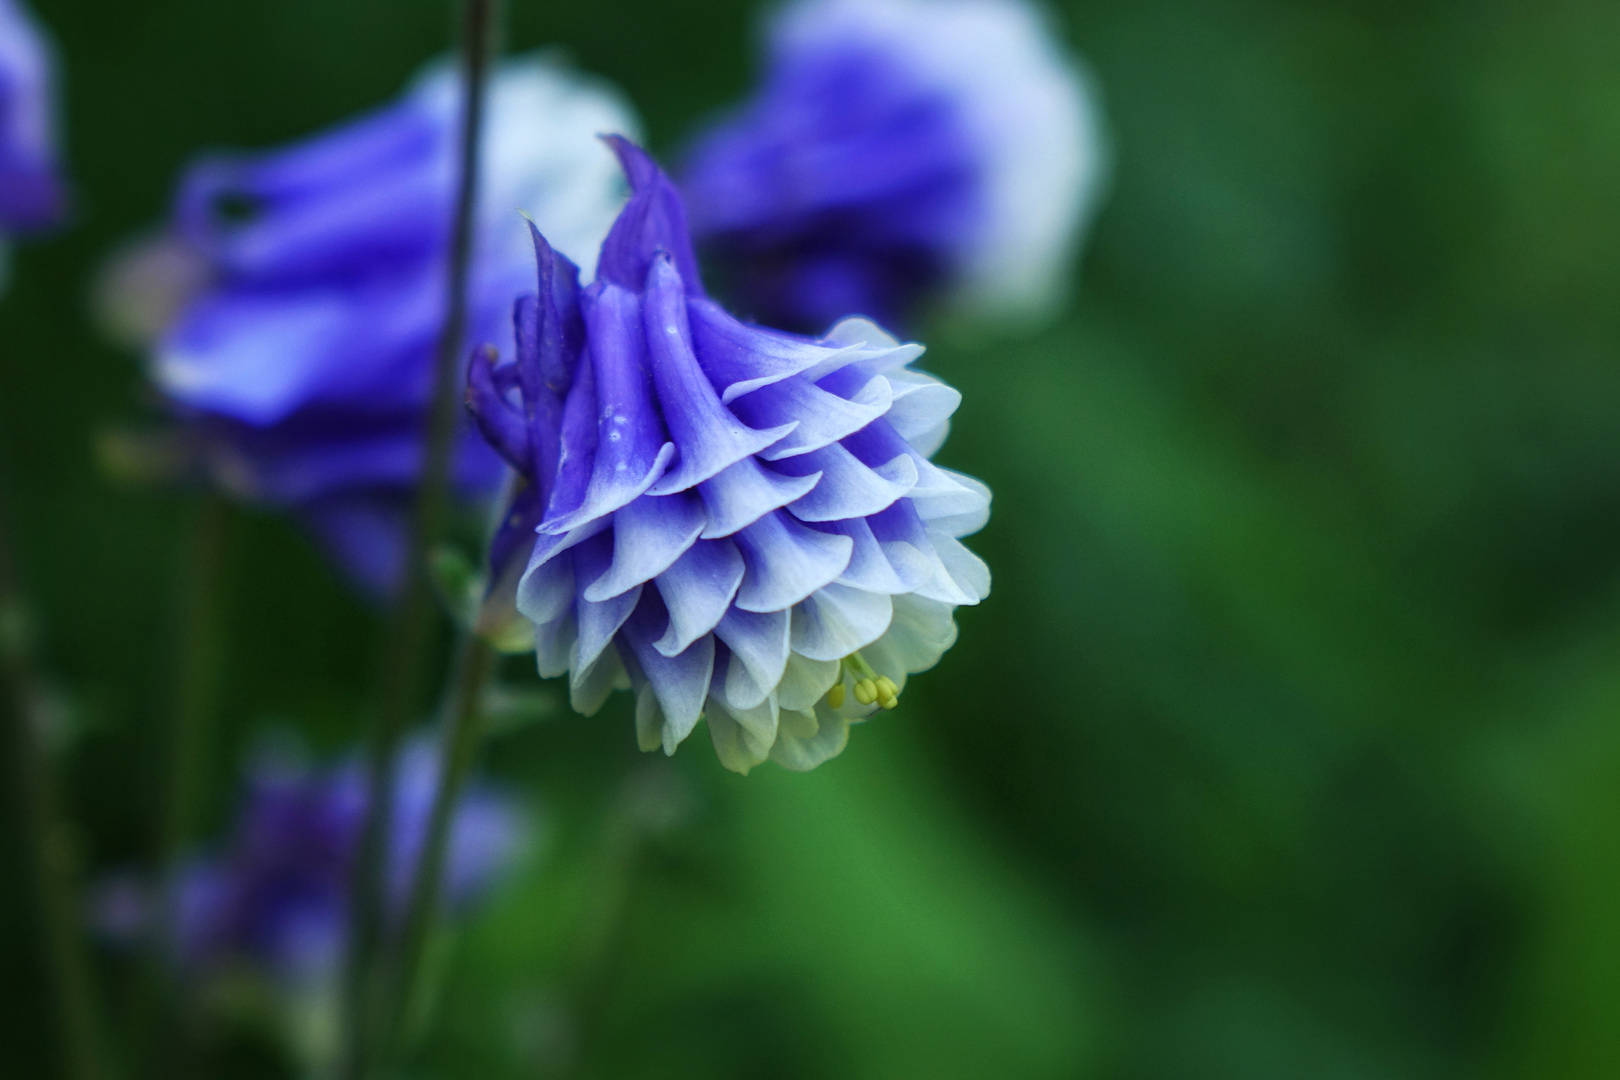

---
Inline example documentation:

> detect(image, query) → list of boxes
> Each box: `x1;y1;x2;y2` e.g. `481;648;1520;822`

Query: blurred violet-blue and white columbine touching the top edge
682;0;1105;332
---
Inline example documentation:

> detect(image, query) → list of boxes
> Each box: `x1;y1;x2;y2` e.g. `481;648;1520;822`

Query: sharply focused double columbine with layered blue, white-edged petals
468;139;990;772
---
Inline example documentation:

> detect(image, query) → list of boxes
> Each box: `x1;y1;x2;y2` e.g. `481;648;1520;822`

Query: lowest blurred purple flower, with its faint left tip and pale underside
96;737;533;1056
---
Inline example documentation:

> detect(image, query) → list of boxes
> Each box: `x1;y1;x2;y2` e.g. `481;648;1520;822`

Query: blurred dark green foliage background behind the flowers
0;0;1620;1080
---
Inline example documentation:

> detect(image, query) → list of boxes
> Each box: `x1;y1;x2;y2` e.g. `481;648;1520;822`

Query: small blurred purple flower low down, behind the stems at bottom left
173;738;527;989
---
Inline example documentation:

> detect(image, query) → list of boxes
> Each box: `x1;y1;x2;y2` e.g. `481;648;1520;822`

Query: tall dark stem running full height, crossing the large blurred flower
342;0;496;1080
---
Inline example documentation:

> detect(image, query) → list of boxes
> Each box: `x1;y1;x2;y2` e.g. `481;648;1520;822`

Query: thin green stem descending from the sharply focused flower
386;633;496;1064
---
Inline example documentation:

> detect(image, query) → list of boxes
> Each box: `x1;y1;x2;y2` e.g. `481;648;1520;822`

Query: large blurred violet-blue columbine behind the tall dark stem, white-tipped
100;58;635;591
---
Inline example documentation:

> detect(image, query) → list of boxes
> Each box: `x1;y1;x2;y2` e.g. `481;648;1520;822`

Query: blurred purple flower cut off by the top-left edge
0;0;65;232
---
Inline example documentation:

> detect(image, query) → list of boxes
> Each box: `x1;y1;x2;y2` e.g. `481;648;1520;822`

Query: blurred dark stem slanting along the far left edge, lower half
0;476;112;1080
